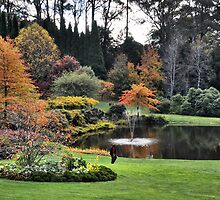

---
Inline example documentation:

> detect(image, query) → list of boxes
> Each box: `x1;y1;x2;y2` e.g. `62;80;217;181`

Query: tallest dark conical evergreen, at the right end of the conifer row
88;21;106;79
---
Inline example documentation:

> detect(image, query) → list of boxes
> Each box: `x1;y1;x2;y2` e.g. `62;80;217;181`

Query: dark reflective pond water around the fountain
75;125;220;160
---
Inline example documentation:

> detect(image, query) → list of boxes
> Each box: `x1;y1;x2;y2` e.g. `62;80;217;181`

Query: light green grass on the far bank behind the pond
95;102;220;126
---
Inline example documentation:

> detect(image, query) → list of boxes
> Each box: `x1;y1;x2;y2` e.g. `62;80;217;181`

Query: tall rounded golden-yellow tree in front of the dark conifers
15;23;60;94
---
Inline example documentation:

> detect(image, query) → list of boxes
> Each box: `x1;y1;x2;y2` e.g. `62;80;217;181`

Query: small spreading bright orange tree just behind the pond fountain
119;83;159;110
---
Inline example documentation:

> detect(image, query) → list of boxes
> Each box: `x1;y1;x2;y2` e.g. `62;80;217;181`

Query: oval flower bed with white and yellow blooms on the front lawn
0;155;117;182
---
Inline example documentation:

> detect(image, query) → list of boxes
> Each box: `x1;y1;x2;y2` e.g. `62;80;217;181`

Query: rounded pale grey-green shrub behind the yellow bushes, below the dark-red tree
52;72;99;97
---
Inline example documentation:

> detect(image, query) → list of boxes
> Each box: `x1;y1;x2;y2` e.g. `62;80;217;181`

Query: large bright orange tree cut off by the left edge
0;37;37;126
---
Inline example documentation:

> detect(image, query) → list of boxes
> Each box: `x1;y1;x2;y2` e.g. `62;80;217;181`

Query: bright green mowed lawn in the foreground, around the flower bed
0;155;220;200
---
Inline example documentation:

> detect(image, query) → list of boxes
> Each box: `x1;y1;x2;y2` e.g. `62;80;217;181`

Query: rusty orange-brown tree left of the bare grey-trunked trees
128;48;162;88
